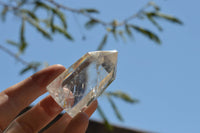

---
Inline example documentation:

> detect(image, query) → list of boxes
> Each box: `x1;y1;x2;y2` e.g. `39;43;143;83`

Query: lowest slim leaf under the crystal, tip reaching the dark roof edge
97;105;113;131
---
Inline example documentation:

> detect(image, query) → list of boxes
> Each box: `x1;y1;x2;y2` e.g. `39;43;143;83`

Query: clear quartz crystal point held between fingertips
47;50;118;117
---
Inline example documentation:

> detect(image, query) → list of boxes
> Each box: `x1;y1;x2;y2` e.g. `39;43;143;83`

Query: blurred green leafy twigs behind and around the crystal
0;0;183;129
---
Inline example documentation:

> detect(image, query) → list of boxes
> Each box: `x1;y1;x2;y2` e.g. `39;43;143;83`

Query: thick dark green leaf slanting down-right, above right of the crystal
129;25;161;44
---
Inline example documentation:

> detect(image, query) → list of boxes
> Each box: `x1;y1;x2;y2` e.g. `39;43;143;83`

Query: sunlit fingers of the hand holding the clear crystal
0;65;97;133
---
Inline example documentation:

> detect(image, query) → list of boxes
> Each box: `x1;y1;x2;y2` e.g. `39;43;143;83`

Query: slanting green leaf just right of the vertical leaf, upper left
27;19;52;40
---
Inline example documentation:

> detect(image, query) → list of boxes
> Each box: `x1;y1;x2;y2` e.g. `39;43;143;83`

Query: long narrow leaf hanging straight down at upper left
19;19;27;53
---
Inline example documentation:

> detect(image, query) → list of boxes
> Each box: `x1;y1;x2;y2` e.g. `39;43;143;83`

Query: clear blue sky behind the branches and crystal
0;0;200;133
